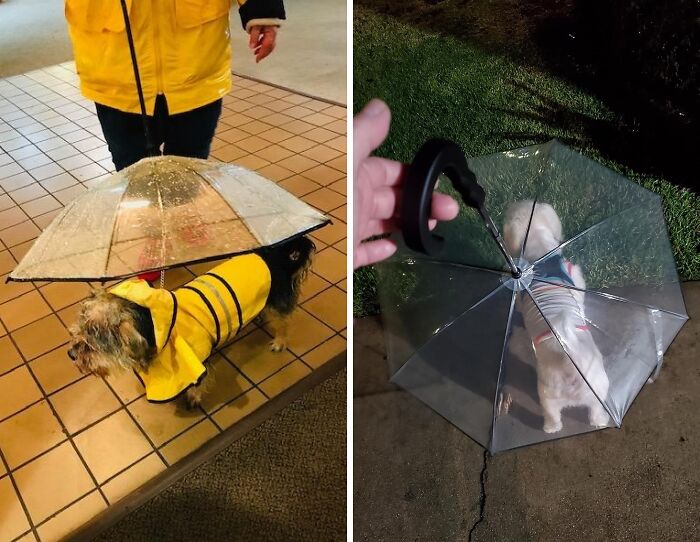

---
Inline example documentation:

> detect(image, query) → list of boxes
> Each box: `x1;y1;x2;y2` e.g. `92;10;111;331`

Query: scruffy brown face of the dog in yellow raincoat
68;291;155;376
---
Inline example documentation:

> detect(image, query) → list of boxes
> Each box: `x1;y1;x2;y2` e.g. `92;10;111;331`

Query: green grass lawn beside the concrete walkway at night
353;7;700;316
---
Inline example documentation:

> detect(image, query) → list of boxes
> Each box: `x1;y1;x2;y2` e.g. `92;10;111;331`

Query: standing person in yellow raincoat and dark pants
65;0;285;170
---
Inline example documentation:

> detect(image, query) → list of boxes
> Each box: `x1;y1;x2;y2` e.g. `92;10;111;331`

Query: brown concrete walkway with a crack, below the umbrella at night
354;282;700;542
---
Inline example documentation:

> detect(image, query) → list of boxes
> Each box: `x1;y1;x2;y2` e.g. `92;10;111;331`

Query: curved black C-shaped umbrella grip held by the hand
401;139;486;255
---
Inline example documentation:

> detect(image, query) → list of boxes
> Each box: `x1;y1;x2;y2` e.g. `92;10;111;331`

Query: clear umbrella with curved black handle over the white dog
379;140;688;452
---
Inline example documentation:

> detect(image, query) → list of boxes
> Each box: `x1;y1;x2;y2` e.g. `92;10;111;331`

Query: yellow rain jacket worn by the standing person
65;0;284;115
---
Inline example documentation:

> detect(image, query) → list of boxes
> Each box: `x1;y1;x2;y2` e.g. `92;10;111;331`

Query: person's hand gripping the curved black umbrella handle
353;100;459;269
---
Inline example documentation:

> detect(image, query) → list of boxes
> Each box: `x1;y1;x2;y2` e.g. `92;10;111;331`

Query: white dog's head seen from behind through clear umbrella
503;200;562;262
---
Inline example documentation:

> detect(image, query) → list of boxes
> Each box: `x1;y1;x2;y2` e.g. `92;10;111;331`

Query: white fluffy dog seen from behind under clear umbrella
503;201;610;433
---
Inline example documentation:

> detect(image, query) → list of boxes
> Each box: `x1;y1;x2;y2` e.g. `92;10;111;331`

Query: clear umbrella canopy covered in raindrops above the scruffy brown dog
9;156;329;281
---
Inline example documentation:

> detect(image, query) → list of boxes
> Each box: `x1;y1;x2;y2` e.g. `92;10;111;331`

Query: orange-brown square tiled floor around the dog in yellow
0;63;347;541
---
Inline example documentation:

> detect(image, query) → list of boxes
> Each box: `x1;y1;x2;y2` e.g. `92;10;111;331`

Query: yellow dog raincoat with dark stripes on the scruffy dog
110;254;270;402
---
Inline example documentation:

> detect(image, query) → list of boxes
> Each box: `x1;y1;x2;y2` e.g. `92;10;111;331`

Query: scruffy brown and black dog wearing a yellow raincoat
68;237;316;407
